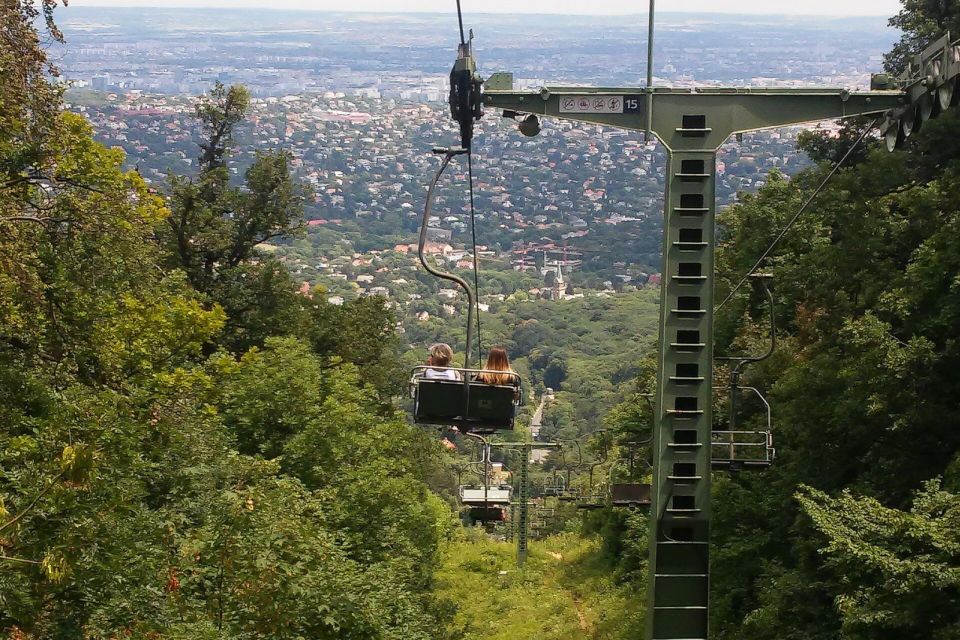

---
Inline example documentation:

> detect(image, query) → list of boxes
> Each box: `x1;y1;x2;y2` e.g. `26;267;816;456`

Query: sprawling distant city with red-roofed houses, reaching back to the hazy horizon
55;7;896;308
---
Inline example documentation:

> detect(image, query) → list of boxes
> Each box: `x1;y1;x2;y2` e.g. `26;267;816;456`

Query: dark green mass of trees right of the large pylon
711;1;960;640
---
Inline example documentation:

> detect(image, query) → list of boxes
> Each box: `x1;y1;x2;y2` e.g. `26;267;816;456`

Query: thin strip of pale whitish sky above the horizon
70;0;900;16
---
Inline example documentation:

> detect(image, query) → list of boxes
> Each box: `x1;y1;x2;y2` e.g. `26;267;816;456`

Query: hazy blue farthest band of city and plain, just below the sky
54;7;895;96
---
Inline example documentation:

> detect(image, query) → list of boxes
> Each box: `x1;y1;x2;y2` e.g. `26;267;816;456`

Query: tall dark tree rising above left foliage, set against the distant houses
160;83;308;351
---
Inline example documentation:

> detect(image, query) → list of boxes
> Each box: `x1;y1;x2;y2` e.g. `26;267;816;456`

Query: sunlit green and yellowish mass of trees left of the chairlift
0;12;453;640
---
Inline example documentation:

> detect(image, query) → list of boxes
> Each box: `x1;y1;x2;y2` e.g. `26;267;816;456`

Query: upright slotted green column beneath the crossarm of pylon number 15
647;145;716;639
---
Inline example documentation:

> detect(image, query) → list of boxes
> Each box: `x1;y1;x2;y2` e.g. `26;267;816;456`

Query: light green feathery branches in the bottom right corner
797;480;960;640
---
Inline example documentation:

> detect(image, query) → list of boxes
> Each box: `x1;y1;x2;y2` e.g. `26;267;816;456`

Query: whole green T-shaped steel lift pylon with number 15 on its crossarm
483;74;924;640
